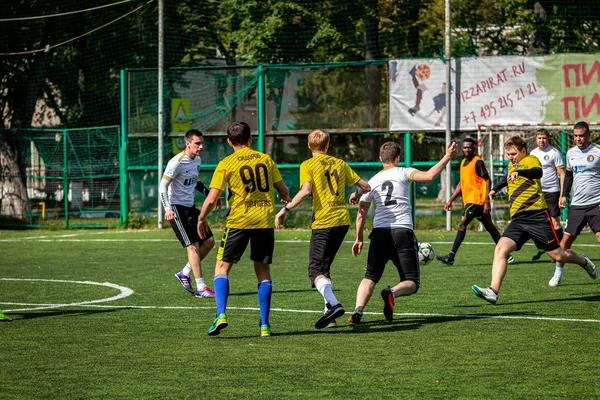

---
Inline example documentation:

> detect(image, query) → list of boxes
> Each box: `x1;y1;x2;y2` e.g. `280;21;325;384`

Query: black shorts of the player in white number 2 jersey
365;228;421;290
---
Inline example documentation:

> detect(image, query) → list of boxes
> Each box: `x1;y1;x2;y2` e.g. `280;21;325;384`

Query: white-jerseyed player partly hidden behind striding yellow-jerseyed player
530;128;565;266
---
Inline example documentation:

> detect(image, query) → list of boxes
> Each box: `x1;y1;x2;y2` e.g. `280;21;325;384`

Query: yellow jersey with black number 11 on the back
300;154;360;229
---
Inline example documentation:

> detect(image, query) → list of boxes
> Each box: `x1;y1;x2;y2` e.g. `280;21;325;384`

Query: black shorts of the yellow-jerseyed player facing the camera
502;210;560;251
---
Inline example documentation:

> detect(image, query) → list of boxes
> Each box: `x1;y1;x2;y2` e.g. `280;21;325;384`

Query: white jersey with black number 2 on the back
360;167;419;229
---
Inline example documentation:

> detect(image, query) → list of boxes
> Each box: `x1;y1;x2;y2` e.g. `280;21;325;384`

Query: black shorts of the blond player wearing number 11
308;225;350;284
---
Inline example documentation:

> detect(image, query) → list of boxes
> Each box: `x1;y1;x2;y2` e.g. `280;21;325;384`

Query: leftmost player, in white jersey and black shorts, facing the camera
159;129;215;297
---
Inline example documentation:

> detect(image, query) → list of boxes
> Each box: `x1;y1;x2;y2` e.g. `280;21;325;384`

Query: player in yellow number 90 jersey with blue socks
198;122;290;336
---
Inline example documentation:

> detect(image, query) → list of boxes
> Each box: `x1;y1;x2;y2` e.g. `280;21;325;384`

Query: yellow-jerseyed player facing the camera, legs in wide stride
472;136;596;304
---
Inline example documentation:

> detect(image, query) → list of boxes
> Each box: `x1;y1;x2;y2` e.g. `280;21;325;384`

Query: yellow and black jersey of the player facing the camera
507;156;548;217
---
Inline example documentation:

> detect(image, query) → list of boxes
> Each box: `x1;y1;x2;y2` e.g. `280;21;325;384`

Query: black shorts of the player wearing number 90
217;228;275;264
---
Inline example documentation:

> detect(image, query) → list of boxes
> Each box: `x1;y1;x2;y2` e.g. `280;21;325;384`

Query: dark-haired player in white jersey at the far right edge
549;122;600;286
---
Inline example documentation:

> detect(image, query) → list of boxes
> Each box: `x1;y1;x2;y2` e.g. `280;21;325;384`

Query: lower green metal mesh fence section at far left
0;126;125;228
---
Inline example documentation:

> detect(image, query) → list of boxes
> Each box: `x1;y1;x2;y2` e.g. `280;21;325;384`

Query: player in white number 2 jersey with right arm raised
348;142;456;324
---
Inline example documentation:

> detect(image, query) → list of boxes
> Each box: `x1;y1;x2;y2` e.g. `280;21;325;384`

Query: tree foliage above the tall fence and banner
0;0;600;129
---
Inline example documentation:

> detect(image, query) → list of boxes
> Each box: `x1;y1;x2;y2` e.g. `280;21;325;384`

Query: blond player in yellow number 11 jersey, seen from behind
275;130;371;329
